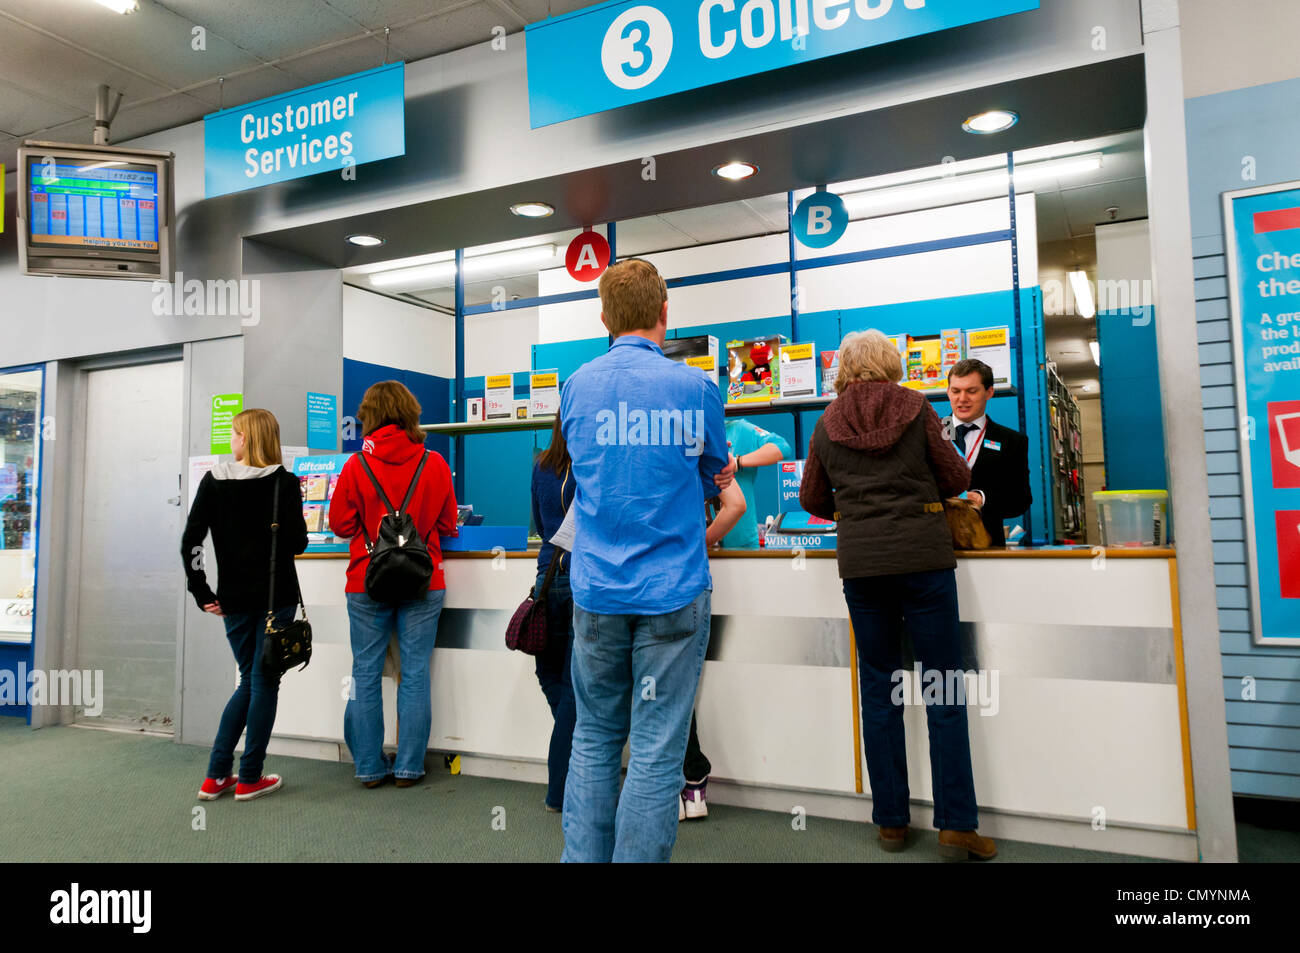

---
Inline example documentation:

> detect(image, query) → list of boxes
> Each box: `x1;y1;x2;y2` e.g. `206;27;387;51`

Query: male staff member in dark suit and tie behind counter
948;358;1034;546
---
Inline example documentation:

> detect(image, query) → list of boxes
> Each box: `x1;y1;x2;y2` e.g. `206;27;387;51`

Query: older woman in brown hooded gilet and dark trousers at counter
800;330;997;859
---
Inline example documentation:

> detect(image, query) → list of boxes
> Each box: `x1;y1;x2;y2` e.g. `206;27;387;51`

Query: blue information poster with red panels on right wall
1223;182;1300;645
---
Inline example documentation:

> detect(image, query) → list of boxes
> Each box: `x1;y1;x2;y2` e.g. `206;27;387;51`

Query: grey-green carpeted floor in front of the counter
0;718;1284;863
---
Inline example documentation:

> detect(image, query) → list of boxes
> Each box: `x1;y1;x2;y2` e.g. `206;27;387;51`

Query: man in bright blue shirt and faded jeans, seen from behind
560;259;735;862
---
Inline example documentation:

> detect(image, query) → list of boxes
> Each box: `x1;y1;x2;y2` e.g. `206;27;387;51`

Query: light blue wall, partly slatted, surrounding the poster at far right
1190;79;1300;798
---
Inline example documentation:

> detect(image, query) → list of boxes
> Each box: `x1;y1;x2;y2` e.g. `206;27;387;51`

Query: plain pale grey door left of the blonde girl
77;361;185;731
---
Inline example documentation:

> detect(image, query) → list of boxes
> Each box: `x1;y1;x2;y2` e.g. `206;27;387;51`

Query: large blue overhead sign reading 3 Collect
525;0;1039;129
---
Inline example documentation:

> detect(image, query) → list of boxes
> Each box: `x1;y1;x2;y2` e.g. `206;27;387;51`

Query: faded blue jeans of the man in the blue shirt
562;589;712;862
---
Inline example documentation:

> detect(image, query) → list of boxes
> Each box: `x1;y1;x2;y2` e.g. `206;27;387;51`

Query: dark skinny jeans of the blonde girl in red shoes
208;606;298;784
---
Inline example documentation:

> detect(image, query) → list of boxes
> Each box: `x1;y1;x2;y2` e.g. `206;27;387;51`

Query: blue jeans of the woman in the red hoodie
343;589;446;781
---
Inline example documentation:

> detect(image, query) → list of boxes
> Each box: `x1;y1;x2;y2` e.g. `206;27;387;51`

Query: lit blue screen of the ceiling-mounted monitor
27;156;159;252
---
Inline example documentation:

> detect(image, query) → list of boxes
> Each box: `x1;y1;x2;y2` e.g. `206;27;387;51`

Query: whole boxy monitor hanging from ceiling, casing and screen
17;142;176;281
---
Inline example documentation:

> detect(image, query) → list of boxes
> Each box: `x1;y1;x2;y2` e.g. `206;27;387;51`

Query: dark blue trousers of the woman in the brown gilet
844;569;979;831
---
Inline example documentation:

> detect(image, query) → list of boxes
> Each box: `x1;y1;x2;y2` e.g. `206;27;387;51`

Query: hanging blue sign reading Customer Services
203;62;406;199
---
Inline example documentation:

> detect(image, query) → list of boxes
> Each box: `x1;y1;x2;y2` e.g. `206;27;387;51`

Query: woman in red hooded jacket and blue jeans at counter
329;381;456;788
